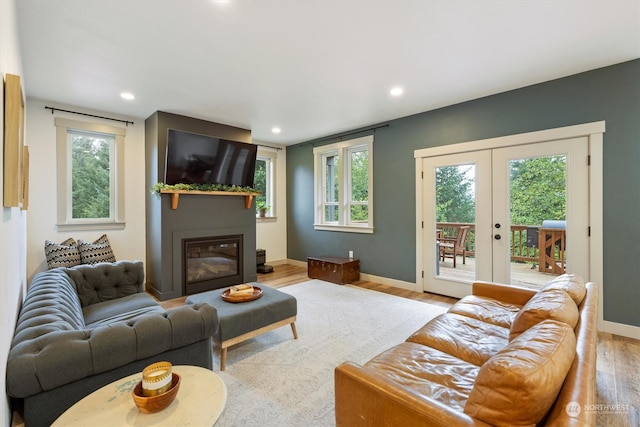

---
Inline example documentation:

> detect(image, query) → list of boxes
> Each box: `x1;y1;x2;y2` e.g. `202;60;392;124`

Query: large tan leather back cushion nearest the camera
464;320;576;426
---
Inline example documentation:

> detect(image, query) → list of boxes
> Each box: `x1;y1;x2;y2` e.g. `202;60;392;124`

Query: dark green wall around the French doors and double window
287;59;640;326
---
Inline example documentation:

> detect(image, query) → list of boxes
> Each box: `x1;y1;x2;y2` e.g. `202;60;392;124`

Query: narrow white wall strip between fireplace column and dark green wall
253;141;287;263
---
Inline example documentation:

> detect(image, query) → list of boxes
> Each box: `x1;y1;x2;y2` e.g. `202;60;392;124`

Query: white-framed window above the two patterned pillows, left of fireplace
55;118;126;229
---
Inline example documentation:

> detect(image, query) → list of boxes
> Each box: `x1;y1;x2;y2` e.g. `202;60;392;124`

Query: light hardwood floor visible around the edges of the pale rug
160;264;640;427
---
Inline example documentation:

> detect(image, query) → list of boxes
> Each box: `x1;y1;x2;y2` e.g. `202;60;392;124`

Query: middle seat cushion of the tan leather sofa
407;313;509;366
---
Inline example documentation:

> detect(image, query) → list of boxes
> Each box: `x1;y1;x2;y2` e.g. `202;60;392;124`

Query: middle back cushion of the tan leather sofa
509;290;580;340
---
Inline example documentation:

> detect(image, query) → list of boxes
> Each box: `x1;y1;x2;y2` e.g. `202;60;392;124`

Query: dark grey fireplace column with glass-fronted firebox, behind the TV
144;111;257;301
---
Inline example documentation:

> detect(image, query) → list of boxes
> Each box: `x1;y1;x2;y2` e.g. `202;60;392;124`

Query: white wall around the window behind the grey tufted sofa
26;98;148;280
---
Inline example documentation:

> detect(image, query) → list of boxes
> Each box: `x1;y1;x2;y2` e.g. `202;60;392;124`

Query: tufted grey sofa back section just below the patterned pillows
61;261;144;308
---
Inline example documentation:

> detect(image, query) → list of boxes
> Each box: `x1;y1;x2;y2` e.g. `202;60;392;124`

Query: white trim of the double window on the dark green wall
313;135;374;234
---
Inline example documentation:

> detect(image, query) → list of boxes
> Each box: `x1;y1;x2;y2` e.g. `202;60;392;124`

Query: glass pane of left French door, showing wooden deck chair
436;164;476;282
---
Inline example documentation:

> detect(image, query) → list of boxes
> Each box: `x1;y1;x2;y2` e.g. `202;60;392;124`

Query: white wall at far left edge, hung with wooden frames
0;0;28;426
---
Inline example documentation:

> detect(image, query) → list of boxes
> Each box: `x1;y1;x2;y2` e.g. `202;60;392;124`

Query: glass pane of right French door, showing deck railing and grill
509;155;567;287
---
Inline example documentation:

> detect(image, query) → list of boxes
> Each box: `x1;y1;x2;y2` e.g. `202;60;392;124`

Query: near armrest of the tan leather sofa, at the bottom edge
335;362;489;427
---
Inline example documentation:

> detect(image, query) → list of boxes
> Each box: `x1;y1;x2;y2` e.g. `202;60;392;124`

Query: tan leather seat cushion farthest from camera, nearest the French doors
449;295;522;328
